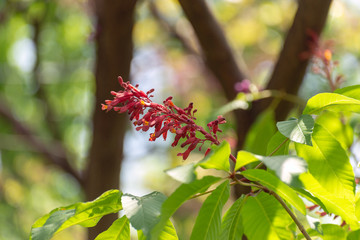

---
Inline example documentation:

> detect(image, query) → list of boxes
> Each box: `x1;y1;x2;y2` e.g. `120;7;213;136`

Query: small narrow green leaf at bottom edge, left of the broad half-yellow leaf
219;195;247;240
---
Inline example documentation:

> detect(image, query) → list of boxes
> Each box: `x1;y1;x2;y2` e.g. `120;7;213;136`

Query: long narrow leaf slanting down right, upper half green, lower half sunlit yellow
242;169;306;215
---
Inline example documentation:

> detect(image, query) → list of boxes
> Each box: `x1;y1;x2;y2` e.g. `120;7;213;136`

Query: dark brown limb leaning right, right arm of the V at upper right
252;0;332;120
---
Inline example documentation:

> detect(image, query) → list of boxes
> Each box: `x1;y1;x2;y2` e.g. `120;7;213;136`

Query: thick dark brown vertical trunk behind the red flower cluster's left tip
85;0;136;239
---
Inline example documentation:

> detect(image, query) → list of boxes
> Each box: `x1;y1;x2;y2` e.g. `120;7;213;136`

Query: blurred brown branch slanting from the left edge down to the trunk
0;99;83;185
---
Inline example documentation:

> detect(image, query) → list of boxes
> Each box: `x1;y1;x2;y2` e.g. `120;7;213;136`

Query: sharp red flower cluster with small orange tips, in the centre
102;77;226;160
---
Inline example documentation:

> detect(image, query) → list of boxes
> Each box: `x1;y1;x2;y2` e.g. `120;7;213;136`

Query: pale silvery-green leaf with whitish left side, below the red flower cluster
121;192;166;235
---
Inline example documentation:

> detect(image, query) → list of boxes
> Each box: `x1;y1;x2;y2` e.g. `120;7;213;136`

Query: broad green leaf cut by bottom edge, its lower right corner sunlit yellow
241;192;293;240
